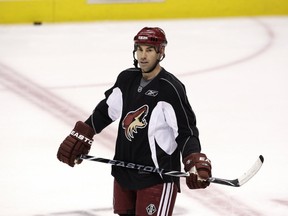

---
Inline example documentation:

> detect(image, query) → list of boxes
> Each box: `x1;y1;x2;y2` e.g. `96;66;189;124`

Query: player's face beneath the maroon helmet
136;45;161;73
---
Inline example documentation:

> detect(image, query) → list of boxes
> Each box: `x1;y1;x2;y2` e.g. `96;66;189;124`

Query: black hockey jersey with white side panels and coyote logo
86;68;201;190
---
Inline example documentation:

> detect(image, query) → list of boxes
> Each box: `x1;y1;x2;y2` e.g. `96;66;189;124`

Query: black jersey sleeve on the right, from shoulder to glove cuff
163;78;201;158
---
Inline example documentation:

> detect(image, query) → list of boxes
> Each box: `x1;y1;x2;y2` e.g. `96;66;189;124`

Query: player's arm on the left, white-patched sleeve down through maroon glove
57;80;122;167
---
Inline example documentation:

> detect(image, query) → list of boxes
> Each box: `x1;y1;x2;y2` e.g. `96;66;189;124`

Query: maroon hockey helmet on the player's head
134;27;167;51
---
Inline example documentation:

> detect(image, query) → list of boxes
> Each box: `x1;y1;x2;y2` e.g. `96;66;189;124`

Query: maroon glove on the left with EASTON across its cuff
57;121;95;167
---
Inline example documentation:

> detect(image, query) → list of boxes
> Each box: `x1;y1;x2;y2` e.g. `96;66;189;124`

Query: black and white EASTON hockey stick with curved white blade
80;155;264;187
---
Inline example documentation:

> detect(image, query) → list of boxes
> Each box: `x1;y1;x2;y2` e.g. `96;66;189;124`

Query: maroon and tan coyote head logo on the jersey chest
122;105;149;141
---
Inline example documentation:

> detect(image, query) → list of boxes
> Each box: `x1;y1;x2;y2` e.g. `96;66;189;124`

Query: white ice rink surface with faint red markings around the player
0;17;288;216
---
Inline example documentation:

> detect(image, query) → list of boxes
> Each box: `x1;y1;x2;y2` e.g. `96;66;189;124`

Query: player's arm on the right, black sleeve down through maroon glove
162;79;211;189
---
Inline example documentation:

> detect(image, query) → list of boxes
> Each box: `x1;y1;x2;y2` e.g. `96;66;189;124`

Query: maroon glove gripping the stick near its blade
183;153;211;189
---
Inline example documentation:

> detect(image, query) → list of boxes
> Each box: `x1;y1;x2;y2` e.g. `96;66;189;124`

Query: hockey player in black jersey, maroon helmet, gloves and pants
57;27;211;216
